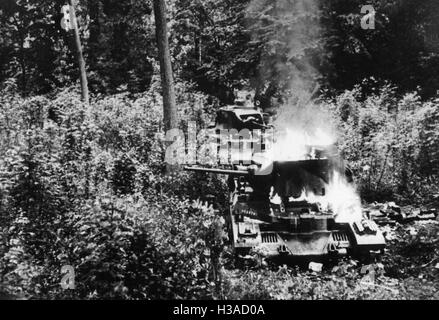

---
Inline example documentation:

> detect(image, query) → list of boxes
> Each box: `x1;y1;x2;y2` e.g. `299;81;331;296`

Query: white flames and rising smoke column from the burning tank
248;0;362;222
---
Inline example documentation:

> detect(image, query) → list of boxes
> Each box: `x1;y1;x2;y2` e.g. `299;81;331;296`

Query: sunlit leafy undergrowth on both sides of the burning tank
0;84;439;299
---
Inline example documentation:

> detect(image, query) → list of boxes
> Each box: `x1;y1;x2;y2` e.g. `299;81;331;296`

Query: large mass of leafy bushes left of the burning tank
0;84;224;299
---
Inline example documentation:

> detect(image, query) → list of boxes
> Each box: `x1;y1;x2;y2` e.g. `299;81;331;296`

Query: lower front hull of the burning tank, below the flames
229;203;385;257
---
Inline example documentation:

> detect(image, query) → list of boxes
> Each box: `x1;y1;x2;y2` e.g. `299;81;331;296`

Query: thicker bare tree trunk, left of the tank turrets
153;0;177;131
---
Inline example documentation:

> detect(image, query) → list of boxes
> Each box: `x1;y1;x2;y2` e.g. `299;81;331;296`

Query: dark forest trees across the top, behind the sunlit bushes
0;0;439;102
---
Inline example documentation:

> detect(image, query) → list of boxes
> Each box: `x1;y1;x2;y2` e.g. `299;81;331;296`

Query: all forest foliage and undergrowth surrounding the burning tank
0;0;439;299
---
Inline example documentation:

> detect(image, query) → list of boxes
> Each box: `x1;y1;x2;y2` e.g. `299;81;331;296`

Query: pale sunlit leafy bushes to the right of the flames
328;85;439;202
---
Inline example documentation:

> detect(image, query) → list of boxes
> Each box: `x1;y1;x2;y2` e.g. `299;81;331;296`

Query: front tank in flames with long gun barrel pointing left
186;159;385;256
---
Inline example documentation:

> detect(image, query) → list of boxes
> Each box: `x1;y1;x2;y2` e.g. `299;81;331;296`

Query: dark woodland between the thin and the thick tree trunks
85;0;157;94
